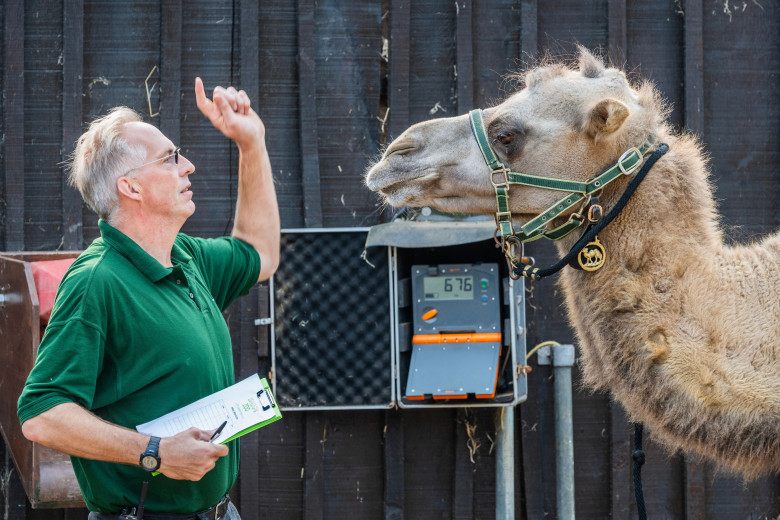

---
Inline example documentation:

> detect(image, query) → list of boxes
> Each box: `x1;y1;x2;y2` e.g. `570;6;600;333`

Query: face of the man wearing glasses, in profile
124;122;195;226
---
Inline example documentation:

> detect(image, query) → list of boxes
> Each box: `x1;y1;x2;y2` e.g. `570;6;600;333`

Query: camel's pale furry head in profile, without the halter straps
365;49;664;220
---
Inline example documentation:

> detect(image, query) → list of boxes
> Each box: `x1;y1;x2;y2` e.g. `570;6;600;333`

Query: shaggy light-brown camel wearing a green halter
365;48;780;480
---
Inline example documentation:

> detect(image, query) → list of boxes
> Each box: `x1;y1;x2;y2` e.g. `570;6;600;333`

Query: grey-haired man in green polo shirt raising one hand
18;78;279;520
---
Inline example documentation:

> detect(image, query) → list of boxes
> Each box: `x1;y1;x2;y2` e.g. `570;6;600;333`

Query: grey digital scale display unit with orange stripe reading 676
404;263;502;400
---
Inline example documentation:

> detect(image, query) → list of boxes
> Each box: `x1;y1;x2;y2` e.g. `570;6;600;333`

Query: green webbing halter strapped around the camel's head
469;109;655;246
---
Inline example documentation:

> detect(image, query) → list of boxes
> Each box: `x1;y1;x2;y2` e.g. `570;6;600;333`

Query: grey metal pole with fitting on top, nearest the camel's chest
552;345;574;520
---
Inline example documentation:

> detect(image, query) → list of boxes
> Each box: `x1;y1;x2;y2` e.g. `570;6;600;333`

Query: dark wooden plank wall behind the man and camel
0;0;780;520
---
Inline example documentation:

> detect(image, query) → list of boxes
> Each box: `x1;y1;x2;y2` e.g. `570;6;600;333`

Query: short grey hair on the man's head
66;107;146;221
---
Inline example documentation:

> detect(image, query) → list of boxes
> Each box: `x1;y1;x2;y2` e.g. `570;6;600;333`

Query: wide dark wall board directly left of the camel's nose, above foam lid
315;2;382;227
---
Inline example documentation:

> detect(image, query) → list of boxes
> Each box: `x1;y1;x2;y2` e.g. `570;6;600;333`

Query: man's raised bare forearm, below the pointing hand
232;141;280;281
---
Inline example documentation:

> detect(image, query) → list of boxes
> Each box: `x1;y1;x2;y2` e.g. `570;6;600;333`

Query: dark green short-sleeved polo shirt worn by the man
18;221;260;512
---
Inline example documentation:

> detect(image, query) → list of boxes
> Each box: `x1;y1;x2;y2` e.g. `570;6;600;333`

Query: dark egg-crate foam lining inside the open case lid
273;229;393;409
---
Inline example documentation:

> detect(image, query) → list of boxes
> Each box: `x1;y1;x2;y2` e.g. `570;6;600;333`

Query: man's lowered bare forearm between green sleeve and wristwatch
22;403;149;464
